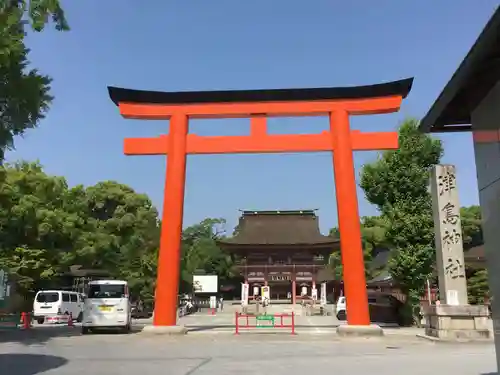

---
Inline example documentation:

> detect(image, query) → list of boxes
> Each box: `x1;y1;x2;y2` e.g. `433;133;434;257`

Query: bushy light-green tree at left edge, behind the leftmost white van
0;162;75;302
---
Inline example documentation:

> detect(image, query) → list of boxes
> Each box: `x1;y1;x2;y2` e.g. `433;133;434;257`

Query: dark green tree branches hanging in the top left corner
0;0;69;164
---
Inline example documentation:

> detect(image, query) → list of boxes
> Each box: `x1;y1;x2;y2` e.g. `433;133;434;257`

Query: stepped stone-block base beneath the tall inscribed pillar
424;305;490;341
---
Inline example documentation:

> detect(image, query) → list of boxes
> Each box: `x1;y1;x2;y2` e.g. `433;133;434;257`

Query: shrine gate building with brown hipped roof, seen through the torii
218;210;340;303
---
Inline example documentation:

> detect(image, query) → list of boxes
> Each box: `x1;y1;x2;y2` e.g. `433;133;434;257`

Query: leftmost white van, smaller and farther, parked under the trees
33;290;85;324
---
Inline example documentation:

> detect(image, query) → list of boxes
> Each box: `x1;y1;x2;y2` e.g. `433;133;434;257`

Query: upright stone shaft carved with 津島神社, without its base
431;165;468;305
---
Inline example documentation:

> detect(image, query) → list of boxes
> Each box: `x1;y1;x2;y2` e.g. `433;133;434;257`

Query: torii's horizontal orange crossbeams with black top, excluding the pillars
108;79;413;155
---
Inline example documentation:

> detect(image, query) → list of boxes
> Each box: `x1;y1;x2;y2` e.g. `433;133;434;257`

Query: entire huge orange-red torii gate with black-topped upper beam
108;78;413;326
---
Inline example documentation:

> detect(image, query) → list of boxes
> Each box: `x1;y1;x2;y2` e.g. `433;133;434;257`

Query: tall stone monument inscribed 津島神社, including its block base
424;165;490;340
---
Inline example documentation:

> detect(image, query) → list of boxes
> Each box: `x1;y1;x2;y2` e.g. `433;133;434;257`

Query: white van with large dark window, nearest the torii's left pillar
82;280;132;334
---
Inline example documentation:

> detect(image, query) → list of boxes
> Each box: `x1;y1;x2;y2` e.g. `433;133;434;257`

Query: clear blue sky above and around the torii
7;0;498;233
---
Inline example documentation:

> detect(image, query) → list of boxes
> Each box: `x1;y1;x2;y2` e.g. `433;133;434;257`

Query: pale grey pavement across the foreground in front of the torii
0;327;496;375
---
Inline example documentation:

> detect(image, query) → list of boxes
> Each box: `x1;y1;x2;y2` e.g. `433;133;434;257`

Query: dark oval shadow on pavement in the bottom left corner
0;354;68;375
